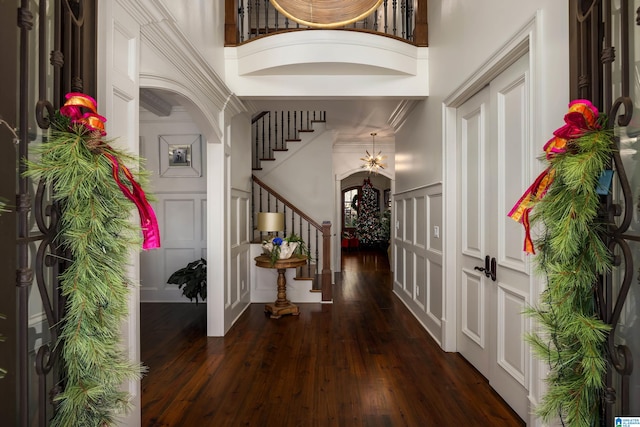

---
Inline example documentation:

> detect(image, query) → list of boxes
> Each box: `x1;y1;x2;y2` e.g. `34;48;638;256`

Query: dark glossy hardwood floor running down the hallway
141;251;524;427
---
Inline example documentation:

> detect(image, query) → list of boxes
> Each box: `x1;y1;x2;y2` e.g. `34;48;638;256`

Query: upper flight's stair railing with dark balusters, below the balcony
251;111;327;170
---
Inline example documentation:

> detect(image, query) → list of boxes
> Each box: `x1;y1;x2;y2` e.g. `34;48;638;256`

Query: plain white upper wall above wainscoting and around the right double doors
396;0;569;326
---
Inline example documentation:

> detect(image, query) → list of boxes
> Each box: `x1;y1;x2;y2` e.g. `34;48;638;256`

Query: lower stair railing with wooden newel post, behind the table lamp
251;175;332;301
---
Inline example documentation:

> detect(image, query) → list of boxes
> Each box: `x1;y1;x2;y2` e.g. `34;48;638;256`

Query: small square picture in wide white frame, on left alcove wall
158;134;202;178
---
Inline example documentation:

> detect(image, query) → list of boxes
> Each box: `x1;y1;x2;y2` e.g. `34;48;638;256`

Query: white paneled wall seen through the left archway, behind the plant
140;108;207;302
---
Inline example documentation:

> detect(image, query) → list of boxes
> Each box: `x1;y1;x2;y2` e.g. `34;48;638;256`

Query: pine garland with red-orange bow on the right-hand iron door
509;100;614;427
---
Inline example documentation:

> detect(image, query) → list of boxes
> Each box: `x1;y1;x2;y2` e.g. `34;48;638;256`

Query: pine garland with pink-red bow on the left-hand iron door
27;93;160;427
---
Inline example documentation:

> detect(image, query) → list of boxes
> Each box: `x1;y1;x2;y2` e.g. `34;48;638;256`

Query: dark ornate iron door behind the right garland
570;0;640;423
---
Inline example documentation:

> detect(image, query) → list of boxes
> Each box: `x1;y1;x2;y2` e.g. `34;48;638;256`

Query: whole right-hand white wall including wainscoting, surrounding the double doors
394;0;569;422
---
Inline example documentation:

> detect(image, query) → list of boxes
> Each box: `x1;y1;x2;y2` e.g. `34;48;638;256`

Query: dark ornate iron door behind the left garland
16;0;96;426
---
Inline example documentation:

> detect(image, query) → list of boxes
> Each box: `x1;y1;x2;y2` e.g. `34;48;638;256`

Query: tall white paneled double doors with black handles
456;55;531;420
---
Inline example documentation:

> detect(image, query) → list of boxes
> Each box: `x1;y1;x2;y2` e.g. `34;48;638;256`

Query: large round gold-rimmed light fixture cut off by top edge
269;0;383;29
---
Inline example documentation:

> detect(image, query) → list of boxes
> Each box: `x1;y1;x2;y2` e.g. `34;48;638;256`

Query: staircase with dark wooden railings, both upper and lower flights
251;111;332;302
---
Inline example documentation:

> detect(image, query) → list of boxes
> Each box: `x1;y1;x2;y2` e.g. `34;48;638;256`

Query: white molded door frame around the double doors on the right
442;11;545;425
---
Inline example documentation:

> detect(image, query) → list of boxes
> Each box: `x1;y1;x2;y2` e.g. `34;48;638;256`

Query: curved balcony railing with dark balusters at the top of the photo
225;0;428;46
